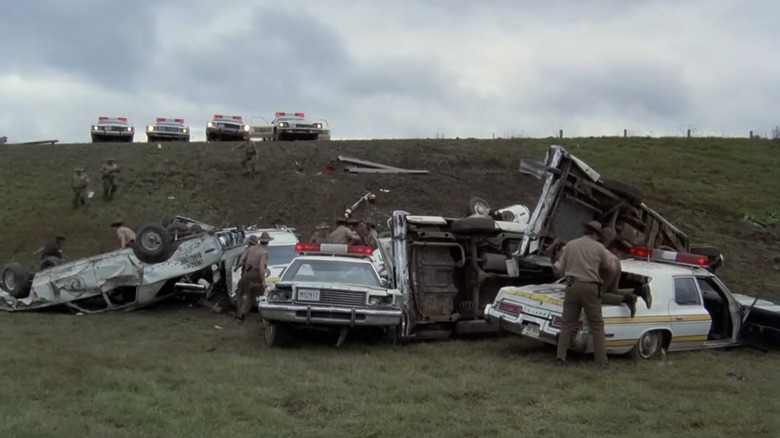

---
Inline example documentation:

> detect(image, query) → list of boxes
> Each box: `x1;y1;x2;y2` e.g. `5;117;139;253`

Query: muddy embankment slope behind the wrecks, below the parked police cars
0;139;780;298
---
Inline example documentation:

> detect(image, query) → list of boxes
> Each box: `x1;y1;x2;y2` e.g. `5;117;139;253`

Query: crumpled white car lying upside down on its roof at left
0;216;244;313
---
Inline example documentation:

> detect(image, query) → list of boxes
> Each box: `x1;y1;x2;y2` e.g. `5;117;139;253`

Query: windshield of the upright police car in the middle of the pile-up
280;258;382;287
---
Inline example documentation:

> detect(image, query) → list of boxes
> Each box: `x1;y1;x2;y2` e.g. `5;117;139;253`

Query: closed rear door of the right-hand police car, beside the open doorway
669;275;712;350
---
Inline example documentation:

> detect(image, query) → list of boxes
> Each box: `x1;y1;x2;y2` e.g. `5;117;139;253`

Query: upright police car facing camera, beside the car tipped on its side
258;243;401;347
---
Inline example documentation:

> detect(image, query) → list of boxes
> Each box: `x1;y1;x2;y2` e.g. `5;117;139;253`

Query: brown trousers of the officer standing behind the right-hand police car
557;281;607;365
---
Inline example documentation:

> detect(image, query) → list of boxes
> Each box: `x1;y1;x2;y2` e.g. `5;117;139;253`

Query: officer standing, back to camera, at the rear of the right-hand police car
553;221;614;368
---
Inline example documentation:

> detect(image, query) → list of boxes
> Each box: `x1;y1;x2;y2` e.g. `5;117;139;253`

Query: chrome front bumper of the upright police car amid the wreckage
257;301;401;327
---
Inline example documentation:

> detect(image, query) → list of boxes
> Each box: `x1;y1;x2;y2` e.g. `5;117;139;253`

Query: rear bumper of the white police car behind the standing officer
484;304;590;352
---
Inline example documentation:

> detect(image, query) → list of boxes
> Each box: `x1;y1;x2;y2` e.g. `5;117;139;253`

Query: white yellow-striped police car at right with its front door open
484;247;780;359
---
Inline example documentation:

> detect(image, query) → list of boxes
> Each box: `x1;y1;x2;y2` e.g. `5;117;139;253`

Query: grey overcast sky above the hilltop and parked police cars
0;0;780;142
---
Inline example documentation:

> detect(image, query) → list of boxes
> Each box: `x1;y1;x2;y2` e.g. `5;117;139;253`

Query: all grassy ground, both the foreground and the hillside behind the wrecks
0;138;780;438
